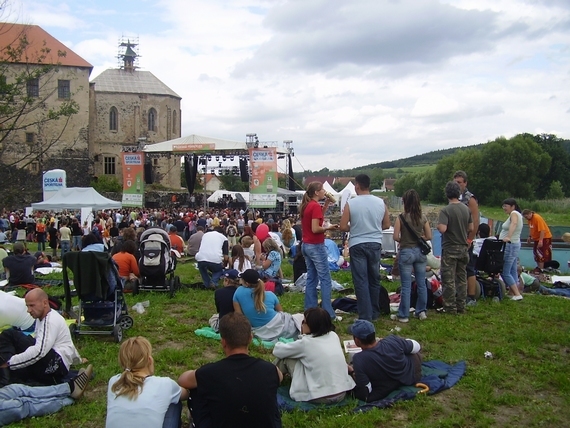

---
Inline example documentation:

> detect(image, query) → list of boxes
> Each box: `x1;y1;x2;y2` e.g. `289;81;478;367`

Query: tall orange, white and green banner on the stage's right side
249;147;277;208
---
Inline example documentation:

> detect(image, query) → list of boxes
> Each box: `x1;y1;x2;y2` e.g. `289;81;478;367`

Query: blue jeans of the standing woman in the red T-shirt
301;243;336;318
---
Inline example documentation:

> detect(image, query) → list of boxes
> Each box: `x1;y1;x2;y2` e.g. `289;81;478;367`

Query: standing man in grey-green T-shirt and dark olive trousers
437;181;473;314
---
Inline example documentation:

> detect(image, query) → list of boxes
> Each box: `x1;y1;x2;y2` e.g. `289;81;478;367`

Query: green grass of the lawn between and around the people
6;263;570;428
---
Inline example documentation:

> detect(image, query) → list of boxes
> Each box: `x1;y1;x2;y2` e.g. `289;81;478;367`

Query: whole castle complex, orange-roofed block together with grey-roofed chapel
0;23;181;196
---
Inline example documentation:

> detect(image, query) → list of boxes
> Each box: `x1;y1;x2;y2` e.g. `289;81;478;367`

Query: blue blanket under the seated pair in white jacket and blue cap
277;360;466;412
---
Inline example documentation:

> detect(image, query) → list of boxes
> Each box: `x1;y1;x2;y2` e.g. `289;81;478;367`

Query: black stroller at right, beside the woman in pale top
475;239;507;300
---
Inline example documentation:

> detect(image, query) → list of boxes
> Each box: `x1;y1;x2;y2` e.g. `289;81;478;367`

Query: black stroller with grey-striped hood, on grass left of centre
137;228;180;297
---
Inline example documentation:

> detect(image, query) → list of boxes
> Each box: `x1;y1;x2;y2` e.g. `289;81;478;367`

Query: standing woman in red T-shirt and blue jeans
300;181;338;318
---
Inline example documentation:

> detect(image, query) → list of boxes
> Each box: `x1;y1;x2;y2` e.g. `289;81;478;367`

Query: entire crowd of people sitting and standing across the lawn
0;171;552;427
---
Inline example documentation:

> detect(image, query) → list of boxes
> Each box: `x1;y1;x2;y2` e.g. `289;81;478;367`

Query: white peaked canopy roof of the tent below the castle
32;187;123;211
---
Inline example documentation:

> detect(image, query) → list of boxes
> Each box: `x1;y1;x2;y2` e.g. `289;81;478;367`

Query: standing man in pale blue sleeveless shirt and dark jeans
340;174;390;321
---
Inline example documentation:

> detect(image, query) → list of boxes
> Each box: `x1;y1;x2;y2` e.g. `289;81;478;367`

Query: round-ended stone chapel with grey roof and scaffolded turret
89;42;181;188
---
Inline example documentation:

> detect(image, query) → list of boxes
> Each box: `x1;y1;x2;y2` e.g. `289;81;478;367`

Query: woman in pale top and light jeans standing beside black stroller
499;198;523;300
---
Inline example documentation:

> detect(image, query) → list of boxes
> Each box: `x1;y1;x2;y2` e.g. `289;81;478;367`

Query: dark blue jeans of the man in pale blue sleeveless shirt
349;242;382;321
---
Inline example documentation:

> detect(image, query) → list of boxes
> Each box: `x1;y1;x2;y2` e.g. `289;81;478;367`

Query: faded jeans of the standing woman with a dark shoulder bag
398;247;427;318
